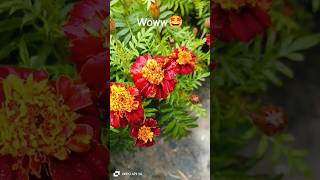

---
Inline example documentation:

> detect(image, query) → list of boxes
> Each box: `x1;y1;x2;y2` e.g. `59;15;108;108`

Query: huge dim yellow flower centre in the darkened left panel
0;75;79;160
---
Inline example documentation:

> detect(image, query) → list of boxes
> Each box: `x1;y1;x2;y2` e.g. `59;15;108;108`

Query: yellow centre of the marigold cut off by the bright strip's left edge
110;85;139;116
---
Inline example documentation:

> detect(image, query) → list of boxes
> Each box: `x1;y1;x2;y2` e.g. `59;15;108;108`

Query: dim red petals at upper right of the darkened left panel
62;0;109;105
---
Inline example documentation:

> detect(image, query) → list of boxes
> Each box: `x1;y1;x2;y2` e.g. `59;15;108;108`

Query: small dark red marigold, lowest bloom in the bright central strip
130;118;160;147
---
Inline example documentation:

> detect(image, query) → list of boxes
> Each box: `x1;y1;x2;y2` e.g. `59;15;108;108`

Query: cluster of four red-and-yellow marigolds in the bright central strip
110;47;196;147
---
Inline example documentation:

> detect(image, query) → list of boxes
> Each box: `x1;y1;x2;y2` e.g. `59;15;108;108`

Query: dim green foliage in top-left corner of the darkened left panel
0;0;74;76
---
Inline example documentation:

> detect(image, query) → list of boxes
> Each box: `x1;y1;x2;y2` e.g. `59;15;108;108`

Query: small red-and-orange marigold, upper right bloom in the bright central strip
171;47;196;74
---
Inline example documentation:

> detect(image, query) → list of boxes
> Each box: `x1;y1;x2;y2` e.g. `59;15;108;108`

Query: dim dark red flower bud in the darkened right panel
252;105;288;136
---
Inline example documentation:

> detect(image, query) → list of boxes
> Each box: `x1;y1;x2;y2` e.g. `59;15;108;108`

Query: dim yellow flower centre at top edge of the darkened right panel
214;0;257;10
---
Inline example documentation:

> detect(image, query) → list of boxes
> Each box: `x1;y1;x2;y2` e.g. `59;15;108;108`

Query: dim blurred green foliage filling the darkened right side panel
211;0;320;180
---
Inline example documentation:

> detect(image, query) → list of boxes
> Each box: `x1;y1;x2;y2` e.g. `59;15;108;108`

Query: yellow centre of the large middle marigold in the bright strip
142;59;164;85
